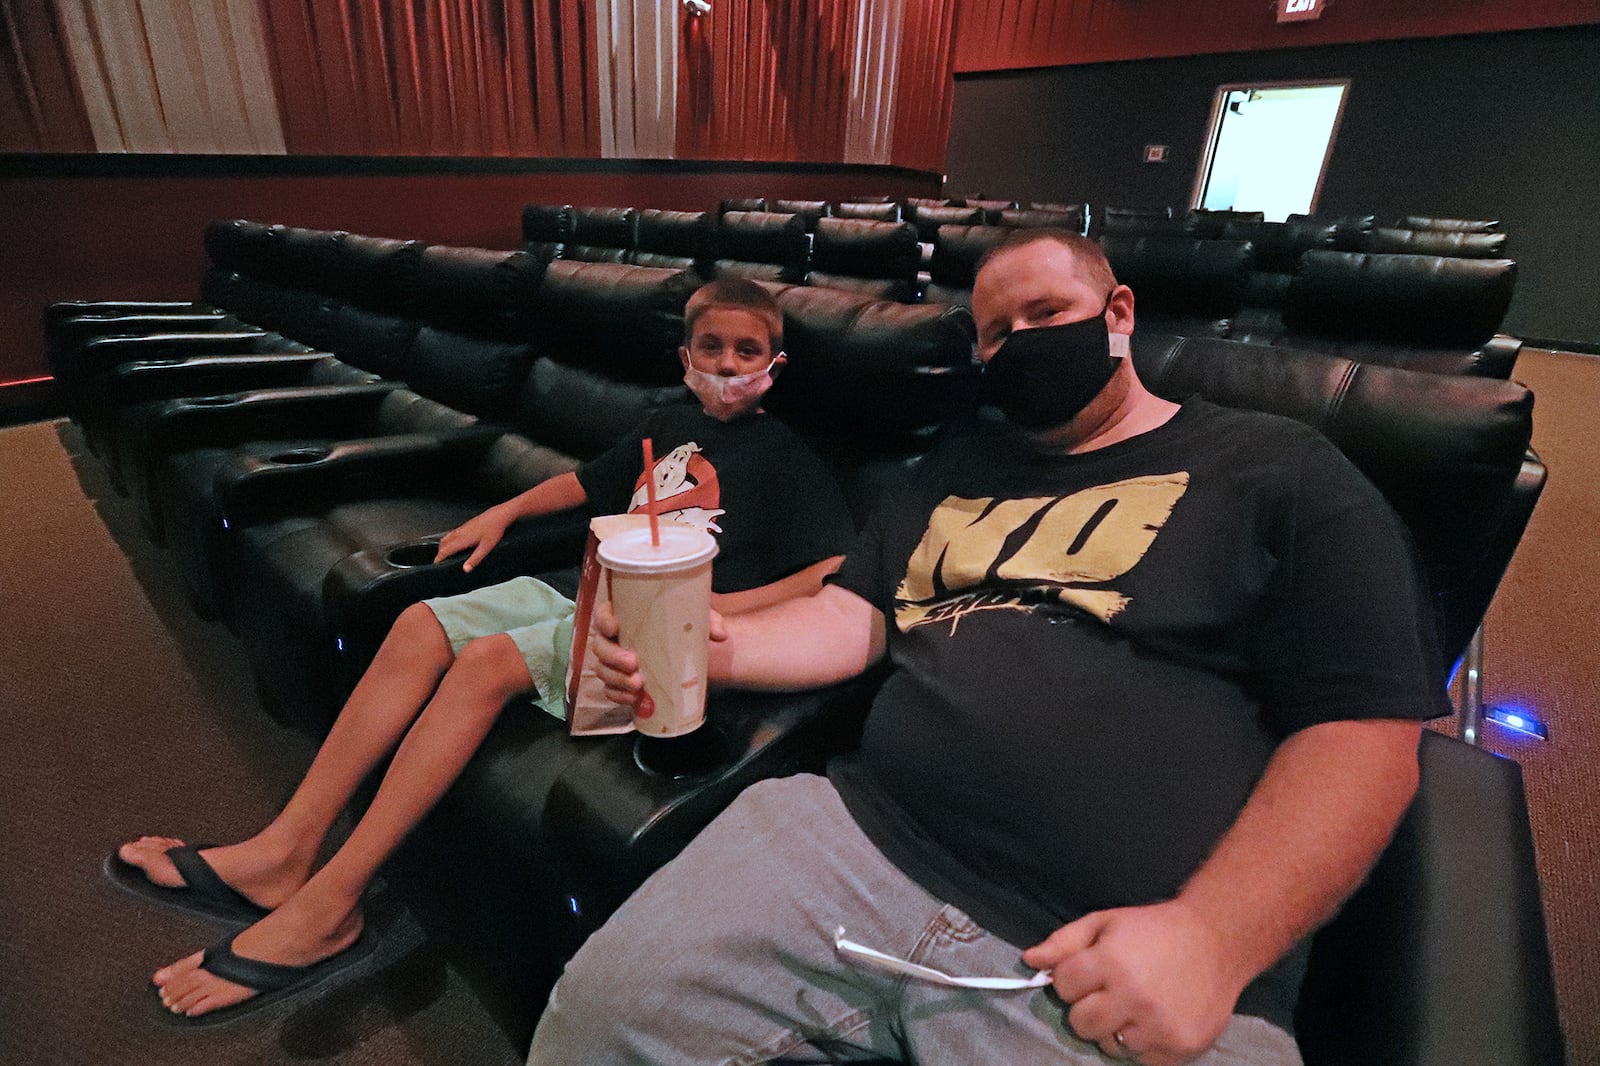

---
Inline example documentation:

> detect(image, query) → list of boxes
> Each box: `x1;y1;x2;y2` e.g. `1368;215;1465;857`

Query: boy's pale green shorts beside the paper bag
422;578;573;720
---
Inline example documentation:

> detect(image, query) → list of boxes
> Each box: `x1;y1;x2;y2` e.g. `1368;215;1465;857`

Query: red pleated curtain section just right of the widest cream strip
261;0;600;157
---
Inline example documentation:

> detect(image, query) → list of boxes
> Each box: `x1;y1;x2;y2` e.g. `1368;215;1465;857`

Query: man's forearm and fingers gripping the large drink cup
594;584;883;706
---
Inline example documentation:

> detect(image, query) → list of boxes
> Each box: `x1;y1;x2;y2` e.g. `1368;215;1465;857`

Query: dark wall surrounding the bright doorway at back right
947;26;1600;351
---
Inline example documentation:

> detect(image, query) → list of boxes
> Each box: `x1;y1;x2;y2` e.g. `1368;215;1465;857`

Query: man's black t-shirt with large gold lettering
829;400;1445;1031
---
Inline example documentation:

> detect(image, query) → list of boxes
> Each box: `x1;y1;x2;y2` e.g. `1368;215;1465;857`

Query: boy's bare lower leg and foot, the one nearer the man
154;634;533;1015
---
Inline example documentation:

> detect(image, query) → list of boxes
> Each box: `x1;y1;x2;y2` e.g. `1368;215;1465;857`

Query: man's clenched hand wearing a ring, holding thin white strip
1022;900;1251;1066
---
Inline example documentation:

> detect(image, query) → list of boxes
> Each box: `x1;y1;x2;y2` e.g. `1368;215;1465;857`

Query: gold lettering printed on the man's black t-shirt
894;472;1189;632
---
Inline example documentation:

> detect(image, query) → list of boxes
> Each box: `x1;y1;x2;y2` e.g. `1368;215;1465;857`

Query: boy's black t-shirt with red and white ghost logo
578;403;854;592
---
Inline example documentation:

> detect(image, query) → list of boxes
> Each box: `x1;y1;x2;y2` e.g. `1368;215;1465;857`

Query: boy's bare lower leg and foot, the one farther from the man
117;603;453;908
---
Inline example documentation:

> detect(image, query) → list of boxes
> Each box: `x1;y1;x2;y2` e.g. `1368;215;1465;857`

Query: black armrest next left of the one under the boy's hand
213;424;501;527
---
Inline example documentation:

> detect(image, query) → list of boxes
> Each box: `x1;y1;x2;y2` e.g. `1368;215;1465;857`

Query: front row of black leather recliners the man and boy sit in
46;221;1560;1066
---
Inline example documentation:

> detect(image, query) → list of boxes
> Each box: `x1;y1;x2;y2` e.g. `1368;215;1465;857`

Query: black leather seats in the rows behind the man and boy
522;200;1522;378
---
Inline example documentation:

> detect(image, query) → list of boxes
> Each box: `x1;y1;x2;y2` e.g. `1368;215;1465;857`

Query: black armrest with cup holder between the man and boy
546;666;886;902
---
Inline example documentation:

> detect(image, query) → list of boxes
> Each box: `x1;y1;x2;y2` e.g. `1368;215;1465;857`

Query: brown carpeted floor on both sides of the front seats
9;351;1600;1066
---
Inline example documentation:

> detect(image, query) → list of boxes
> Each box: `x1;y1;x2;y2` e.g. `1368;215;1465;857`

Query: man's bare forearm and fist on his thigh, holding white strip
1022;719;1421;1066
